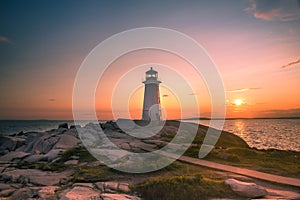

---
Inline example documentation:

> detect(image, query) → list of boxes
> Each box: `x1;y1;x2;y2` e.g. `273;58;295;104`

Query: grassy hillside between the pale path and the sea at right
160;121;300;178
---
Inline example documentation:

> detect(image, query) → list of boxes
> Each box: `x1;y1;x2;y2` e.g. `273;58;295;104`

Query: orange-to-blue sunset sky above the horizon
0;0;300;119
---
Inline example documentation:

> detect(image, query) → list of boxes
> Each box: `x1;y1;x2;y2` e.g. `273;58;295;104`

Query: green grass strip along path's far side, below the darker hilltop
185;141;300;178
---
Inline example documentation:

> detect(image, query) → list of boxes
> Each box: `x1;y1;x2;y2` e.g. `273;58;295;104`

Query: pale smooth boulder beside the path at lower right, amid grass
225;179;268;198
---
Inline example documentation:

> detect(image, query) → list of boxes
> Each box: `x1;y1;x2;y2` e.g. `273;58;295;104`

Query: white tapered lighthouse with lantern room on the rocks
142;67;161;121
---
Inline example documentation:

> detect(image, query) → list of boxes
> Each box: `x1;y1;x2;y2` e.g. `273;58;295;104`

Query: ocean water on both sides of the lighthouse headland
0;119;300;152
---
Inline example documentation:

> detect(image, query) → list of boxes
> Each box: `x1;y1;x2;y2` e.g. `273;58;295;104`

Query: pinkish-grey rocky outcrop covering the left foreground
0;122;144;200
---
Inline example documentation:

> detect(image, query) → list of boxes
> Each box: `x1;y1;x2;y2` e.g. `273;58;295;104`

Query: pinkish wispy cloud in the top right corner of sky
245;0;300;21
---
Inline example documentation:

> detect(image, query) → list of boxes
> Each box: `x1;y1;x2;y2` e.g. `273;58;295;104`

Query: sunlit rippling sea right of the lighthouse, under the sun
185;119;300;151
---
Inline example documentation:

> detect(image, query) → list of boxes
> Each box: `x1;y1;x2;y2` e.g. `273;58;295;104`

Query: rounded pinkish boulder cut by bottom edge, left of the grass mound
60;186;101;200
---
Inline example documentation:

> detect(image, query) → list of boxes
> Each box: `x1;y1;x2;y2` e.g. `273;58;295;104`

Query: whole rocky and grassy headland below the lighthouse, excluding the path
0;121;300;200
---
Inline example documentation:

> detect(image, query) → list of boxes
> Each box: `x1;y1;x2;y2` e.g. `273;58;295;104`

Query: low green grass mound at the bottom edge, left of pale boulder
131;174;237;200
